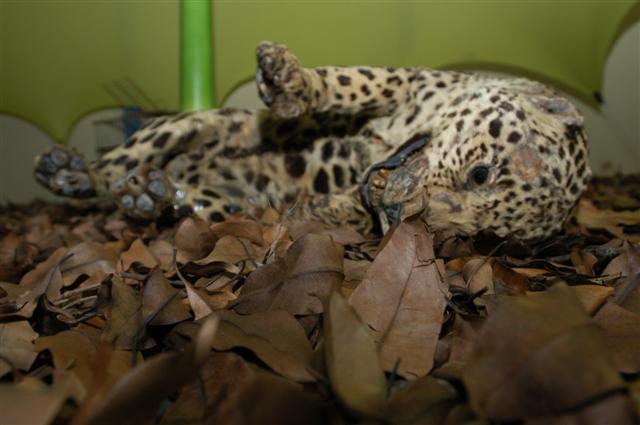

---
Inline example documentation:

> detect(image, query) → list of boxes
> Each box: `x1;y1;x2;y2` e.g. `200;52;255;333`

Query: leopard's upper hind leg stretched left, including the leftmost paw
34;109;268;198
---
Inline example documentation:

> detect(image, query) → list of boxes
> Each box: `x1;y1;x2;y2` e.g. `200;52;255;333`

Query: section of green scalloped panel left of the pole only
0;0;179;141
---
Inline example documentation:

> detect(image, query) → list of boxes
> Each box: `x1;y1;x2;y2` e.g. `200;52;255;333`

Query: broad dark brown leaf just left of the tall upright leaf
233;234;344;315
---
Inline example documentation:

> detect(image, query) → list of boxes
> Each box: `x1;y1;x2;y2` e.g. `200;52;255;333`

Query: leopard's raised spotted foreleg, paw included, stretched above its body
256;42;420;118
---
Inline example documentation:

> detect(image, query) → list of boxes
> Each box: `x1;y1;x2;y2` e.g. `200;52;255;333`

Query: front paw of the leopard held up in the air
256;42;309;118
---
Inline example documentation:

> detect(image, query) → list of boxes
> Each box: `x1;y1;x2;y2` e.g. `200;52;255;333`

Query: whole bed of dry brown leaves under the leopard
0;177;640;424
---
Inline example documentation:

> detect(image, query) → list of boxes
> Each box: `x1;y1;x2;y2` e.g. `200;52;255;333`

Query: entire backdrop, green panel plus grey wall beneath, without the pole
0;0;640;201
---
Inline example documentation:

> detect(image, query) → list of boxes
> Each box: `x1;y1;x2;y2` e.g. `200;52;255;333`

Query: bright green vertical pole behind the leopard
180;0;213;111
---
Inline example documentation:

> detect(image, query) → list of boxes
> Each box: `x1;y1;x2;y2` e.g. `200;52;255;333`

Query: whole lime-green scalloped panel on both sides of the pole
0;0;638;141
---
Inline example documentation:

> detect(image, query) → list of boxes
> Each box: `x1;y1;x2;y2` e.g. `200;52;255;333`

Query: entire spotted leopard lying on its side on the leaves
35;43;591;239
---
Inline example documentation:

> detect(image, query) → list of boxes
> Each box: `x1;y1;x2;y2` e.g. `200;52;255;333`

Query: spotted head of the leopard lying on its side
362;79;591;240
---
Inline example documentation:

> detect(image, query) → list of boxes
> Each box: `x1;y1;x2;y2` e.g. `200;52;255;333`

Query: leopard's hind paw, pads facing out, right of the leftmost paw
115;165;176;220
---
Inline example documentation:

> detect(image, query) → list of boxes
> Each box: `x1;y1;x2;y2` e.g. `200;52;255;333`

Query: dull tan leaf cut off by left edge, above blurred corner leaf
0;320;38;377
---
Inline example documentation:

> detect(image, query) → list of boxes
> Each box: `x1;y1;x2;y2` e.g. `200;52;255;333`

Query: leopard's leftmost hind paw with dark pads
33;145;96;198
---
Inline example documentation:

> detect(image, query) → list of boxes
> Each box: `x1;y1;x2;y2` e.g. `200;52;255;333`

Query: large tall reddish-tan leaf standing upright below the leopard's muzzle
349;220;448;379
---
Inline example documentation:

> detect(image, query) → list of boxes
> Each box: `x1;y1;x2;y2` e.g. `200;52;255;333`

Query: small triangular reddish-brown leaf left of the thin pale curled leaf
142;268;191;325
